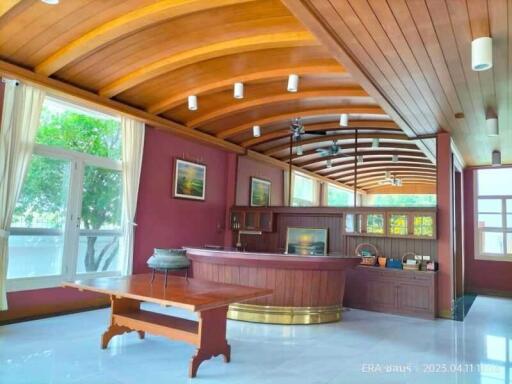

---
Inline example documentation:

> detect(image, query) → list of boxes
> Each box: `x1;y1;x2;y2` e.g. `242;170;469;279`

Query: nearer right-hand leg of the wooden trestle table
189;306;231;377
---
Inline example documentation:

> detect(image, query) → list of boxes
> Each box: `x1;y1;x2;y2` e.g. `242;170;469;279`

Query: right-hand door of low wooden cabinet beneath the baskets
398;283;434;316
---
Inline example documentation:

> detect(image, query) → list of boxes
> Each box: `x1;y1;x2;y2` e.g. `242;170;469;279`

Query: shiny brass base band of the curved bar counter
228;304;342;324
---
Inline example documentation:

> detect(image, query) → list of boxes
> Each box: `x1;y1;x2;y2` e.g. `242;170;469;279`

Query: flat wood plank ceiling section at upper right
283;0;512;166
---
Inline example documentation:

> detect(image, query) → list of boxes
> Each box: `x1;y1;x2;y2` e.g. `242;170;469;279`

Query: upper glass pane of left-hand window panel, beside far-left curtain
11;155;70;229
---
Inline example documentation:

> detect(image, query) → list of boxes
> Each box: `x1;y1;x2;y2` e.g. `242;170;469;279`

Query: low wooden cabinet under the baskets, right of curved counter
343;266;437;318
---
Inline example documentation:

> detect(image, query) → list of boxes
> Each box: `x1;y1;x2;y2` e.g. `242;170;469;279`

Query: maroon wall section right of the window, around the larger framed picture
133;128;236;273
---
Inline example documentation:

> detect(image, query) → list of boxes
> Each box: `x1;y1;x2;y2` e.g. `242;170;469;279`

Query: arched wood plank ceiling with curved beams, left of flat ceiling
0;0;436;190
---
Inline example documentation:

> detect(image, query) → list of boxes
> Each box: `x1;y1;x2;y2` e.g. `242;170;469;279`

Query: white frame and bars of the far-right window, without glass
473;171;512;262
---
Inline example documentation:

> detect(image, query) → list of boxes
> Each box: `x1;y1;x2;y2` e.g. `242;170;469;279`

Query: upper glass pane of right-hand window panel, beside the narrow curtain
80;166;122;230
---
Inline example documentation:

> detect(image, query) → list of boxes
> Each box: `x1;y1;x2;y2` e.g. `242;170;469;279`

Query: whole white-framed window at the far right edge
475;168;512;261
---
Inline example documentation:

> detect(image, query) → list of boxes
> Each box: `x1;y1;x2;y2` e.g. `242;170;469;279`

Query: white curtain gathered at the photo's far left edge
0;80;45;310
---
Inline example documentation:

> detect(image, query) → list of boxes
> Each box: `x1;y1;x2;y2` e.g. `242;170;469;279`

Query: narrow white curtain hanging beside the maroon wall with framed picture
121;117;144;275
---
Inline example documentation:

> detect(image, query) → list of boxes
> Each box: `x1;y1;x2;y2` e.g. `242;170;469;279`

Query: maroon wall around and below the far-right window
464;169;512;294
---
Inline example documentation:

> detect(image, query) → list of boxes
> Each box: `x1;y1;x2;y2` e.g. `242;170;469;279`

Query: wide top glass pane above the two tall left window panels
36;98;121;159
